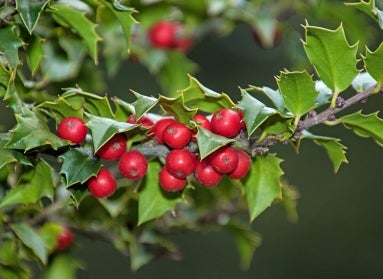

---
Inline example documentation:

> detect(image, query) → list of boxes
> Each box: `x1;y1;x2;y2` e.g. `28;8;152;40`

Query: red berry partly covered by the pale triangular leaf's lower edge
208;145;238;173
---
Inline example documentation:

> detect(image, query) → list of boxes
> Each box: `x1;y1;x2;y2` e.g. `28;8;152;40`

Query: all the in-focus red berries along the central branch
57;108;251;198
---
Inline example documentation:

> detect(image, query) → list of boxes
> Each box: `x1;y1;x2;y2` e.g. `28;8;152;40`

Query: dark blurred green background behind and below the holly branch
67;22;383;279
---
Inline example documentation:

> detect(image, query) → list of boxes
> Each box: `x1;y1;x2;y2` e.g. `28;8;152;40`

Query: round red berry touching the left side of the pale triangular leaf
162;122;192;149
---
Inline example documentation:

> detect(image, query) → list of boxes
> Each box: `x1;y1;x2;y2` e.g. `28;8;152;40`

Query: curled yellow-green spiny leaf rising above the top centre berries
181;76;235;113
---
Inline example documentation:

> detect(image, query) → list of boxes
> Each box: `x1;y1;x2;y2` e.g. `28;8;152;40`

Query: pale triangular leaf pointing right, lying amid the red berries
197;126;235;160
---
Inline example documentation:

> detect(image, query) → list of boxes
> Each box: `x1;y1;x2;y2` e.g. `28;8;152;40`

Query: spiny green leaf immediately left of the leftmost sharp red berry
5;107;68;151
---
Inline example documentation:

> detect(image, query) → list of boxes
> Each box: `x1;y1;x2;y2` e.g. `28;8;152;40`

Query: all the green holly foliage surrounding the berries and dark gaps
0;0;383;279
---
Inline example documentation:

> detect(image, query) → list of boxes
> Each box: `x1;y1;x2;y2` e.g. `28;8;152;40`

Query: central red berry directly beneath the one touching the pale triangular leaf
165;149;197;178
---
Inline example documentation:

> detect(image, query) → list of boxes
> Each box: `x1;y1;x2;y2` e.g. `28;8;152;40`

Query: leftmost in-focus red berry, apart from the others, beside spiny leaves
57;116;87;144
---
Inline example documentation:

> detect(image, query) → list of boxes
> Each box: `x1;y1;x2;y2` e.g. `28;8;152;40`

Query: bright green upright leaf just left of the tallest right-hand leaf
277;71;318;119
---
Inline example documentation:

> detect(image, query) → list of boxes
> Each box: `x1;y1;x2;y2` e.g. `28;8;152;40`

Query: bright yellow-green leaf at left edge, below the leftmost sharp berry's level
0;160;55;207
